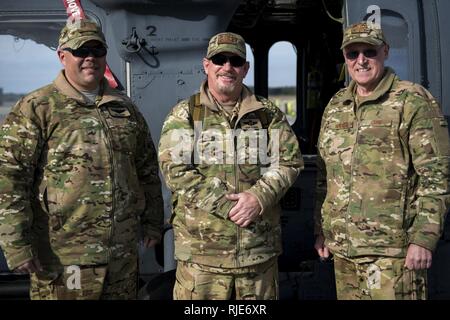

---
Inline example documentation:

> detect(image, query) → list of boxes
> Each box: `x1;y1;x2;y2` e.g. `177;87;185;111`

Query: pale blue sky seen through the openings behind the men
0;35;296;93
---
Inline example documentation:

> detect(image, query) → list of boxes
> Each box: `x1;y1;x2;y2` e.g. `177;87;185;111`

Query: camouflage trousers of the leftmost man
30;256;138;300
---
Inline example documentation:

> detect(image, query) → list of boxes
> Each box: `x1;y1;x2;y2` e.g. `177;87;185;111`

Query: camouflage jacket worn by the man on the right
315;68;450;257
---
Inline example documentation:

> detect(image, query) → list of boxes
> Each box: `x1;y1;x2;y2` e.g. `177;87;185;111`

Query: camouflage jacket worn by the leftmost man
0;72;163;269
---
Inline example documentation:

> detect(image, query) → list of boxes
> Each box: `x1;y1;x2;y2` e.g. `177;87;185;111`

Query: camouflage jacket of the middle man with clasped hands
159;83;303;268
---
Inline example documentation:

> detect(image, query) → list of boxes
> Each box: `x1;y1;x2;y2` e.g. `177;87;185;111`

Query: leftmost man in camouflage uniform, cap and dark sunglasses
0;20;163;299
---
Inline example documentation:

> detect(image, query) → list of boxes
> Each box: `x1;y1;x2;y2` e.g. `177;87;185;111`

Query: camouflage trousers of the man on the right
334;255;427;300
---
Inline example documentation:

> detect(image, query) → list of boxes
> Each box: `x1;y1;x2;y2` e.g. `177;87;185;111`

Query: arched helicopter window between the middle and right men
269;41;297;125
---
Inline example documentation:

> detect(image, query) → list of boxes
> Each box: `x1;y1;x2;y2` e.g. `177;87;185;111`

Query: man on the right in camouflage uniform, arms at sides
315;22;450;299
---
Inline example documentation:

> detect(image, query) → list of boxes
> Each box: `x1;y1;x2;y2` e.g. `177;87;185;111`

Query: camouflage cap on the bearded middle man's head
206;32;246;59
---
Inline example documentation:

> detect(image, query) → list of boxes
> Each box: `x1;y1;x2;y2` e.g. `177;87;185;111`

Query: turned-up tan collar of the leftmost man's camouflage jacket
53;70;127;107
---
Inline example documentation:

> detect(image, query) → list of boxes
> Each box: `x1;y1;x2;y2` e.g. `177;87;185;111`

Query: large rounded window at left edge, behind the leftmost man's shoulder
0;35;61;121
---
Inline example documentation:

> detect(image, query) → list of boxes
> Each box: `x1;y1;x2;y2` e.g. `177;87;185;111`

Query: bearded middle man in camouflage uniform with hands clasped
159;32;303;300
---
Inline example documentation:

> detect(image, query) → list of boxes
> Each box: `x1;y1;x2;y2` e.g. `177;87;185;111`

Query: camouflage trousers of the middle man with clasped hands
173;258;278;300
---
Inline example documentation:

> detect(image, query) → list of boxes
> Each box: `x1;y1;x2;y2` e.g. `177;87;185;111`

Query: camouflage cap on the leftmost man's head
59;19;108;49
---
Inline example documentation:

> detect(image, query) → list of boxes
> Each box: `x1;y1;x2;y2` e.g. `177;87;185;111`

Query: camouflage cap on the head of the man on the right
341;22;386;49
